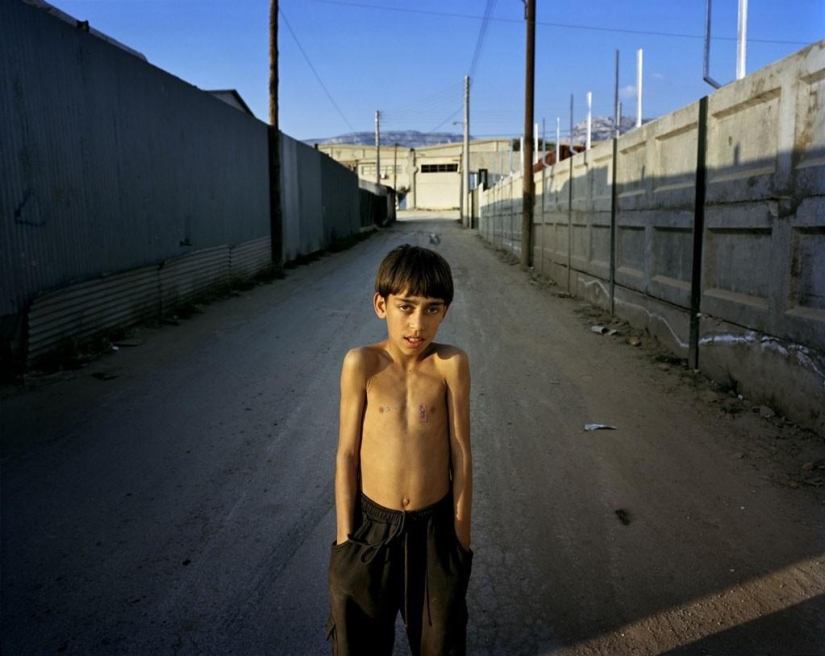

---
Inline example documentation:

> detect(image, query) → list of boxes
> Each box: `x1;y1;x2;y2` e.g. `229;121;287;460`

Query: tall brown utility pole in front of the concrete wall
521;0;536;269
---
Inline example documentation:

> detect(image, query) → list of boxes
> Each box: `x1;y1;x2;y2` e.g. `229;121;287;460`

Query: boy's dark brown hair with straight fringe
375;244;453;305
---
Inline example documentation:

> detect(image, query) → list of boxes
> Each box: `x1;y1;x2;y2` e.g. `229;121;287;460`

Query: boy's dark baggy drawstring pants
327;495;473;656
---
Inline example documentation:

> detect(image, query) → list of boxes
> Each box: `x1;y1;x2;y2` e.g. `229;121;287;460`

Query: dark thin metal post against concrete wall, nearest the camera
688;96;708;369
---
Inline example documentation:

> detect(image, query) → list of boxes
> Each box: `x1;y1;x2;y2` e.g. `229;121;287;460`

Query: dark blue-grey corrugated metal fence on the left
0;0;386;368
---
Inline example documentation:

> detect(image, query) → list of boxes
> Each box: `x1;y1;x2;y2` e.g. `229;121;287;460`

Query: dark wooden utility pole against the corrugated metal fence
267;0;283;271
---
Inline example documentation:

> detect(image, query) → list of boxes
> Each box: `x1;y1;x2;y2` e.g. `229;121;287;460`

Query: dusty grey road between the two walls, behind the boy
0;221;825;656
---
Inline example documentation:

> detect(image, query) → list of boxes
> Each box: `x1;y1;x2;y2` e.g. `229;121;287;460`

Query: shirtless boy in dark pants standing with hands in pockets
327;245;473;656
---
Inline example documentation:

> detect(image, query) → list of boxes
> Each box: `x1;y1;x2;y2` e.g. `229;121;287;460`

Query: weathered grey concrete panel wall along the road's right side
480;41;825;432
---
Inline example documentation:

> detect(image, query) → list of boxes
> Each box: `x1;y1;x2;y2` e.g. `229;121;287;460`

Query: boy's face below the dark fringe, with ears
373;292;447;355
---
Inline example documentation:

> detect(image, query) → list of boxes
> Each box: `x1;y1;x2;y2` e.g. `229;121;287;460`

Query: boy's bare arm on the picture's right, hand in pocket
447;349;473;549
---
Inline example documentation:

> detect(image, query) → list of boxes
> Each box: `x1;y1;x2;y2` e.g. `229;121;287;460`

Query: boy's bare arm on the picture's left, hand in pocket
335;349;366;544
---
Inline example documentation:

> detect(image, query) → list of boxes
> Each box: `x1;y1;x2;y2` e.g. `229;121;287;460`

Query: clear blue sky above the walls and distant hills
50;0;825;139
